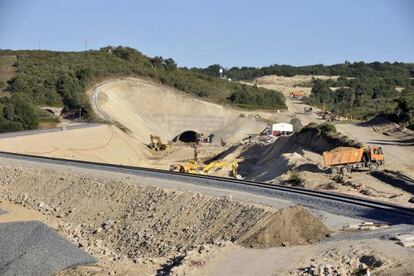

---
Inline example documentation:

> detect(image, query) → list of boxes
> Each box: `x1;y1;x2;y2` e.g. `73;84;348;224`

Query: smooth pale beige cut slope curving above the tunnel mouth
93;78;266;143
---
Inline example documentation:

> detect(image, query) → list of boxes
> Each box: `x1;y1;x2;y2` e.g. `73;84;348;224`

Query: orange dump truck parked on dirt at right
323;146;384;174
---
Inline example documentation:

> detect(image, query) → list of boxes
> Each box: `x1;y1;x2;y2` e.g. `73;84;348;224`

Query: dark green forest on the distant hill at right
199;62;414;125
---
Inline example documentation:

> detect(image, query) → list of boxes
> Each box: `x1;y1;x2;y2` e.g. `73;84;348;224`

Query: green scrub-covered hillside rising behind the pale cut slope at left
0;47;286;132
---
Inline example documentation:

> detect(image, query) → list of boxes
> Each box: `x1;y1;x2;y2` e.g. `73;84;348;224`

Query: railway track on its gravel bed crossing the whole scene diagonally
0;152;414;224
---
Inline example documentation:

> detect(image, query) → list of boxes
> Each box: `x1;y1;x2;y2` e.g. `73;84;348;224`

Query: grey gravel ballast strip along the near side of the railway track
0;152;414;224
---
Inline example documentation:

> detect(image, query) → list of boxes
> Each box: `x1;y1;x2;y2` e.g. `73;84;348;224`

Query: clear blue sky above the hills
0;0;414;67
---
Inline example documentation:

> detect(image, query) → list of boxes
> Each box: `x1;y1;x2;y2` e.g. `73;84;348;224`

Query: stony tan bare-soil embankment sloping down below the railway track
0;165;330;273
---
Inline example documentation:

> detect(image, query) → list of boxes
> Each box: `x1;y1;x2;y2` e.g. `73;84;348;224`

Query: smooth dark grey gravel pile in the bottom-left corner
0;221;95;275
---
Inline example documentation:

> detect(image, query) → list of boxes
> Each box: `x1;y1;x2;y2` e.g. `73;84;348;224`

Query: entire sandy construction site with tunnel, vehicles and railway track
0;73;414;275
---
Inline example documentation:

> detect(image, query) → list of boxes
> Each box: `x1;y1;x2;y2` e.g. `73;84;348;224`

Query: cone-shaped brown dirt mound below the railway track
238;206;330;248
